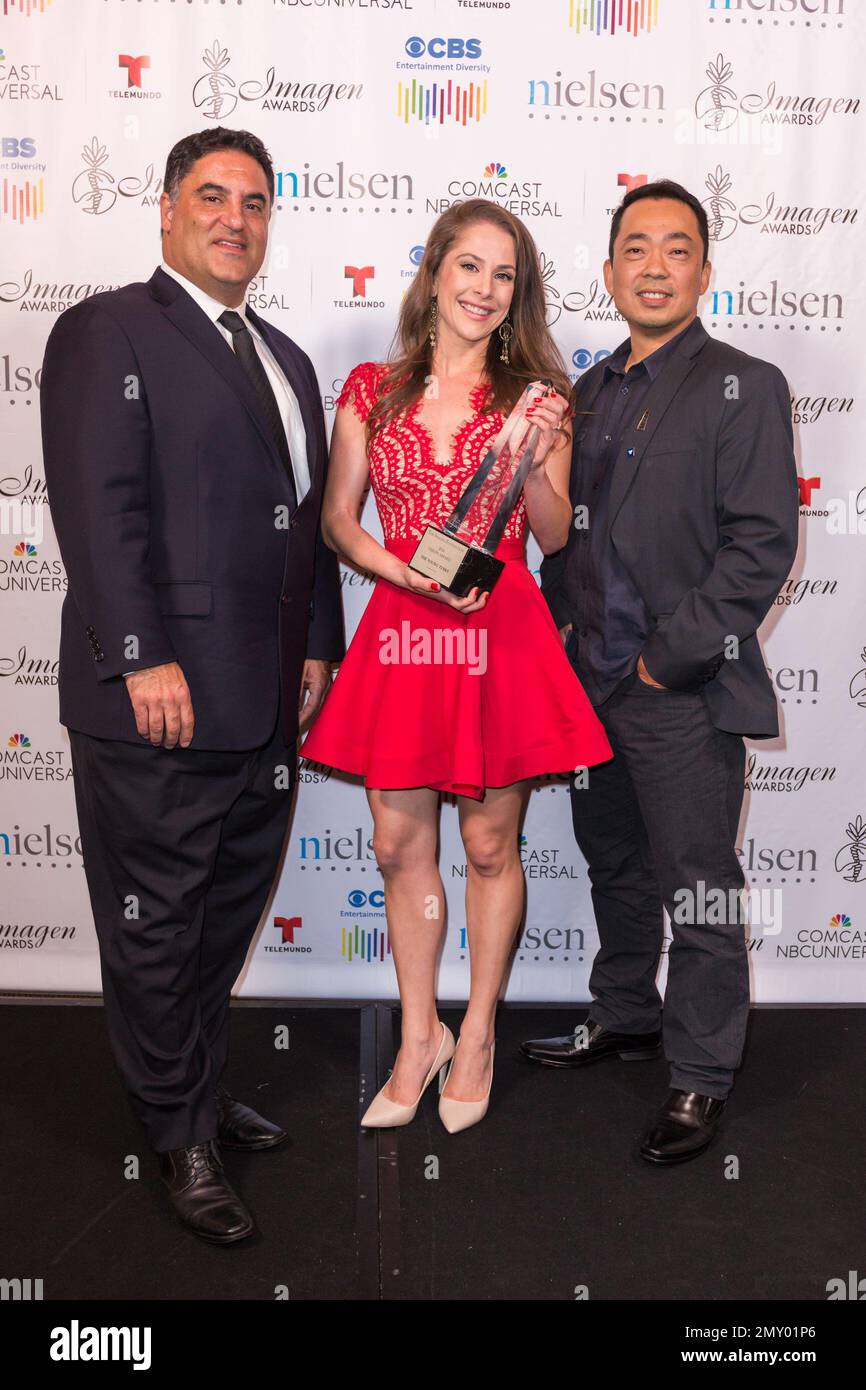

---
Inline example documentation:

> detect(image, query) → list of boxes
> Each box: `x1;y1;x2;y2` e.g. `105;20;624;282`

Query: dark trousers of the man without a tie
571;677;749;1098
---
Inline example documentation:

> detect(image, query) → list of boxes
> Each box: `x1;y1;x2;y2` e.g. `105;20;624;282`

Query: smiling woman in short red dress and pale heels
302;199;612;1133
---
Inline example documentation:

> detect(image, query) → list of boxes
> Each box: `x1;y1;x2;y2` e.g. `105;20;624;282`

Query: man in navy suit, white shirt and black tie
42;128;343;1244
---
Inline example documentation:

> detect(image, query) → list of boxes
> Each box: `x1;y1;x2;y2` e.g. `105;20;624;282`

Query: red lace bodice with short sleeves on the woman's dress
336;361;527;541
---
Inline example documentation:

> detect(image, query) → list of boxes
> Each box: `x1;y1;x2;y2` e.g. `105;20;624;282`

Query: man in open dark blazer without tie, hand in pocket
523;179;798;1163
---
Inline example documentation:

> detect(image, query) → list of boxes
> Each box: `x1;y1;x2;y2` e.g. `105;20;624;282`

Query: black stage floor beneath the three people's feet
0;1001;866;1301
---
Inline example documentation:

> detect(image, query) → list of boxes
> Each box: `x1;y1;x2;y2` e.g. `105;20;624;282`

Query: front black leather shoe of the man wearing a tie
158;1138;253;1245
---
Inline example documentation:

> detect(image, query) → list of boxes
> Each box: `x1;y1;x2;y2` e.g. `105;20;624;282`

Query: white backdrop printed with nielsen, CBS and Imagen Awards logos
0;0;866;1001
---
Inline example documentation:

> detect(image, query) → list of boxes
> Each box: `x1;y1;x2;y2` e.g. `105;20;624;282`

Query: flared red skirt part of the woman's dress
300;539;613;801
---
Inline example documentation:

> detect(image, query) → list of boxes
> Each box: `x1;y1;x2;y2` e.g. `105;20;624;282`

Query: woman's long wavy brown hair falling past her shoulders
367;197;571;438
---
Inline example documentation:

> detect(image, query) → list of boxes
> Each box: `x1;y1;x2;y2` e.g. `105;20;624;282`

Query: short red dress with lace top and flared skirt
302;361;613;801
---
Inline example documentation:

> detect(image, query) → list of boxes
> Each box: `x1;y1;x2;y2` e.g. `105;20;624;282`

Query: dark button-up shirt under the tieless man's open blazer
569;324;691;705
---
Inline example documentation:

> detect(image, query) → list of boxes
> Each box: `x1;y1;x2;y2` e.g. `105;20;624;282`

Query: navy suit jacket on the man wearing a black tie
42;268;345;751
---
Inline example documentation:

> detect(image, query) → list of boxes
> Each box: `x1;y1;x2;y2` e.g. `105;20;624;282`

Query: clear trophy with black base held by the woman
409;381;552;599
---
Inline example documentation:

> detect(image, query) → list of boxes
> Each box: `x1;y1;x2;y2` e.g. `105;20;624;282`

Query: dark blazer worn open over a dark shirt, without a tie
541;318;799;737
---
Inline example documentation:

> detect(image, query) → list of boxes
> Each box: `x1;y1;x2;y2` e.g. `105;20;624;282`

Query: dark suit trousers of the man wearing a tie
70;692;296;1150
